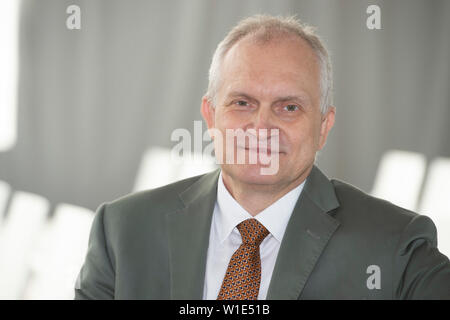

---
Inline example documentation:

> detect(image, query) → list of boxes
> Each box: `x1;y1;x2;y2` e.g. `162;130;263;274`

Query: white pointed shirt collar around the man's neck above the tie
217;171;306;243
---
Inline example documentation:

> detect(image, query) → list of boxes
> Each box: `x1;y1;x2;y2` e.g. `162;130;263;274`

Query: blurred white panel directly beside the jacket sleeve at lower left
23;204;94;300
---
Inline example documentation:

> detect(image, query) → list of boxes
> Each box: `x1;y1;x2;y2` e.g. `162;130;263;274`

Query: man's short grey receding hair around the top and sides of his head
205;15;333;113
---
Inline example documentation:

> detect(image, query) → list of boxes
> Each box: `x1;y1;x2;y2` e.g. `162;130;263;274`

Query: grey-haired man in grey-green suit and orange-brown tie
75;16;450;299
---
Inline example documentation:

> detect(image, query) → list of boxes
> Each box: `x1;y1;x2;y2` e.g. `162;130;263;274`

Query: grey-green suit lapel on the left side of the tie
167;170;220;299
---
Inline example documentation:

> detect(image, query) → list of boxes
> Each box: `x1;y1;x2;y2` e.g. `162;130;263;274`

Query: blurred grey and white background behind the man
0;0;450;299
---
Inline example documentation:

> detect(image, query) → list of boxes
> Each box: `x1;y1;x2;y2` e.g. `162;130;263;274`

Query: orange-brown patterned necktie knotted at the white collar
217;219;269;300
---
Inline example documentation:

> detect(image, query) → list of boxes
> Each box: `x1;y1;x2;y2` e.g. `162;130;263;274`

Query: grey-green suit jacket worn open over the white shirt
75;166;450;299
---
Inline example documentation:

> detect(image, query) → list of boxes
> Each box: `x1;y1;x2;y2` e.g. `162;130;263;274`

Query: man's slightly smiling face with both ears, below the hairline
202;37;334;185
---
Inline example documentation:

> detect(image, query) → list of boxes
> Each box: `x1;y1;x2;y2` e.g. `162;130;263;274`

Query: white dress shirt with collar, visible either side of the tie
203;172;306;300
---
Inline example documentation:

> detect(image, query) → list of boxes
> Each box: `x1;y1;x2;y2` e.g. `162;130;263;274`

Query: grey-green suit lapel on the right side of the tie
267;166;339;300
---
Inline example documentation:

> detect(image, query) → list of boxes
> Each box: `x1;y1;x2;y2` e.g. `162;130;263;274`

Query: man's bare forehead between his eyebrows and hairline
219;36;320;101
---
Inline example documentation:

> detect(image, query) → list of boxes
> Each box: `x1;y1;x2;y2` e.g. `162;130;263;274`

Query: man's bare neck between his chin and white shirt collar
222;166;312;217
